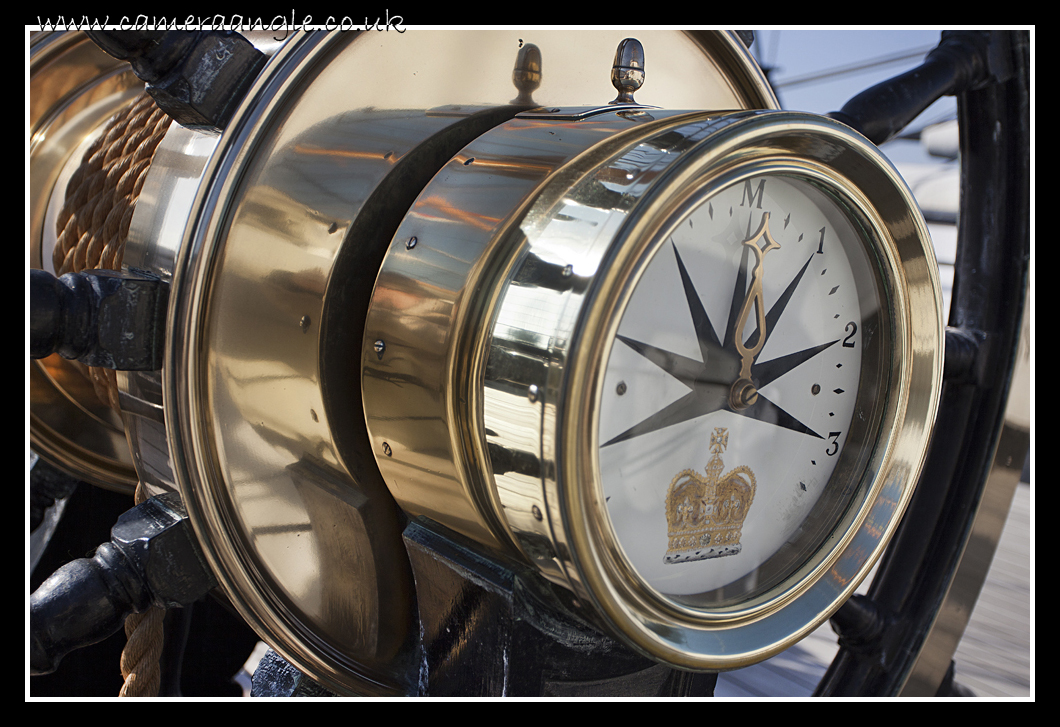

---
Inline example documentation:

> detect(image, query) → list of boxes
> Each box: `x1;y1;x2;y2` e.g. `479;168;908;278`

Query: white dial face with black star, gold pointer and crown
599;174;889;608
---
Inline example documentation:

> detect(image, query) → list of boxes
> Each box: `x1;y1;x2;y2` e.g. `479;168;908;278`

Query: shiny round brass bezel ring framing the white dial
557;112;943;670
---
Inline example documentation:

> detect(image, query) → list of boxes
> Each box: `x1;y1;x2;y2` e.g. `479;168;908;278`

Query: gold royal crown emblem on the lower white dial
664;427;755;563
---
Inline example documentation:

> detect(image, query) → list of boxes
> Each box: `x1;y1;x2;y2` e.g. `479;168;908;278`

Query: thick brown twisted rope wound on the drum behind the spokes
52;92;170;696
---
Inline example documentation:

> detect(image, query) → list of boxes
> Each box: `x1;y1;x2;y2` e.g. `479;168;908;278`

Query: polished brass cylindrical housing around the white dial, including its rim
361;108;942;670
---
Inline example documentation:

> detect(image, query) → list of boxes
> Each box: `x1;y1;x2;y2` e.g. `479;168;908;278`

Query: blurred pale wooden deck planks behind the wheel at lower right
714;483;1031;698
